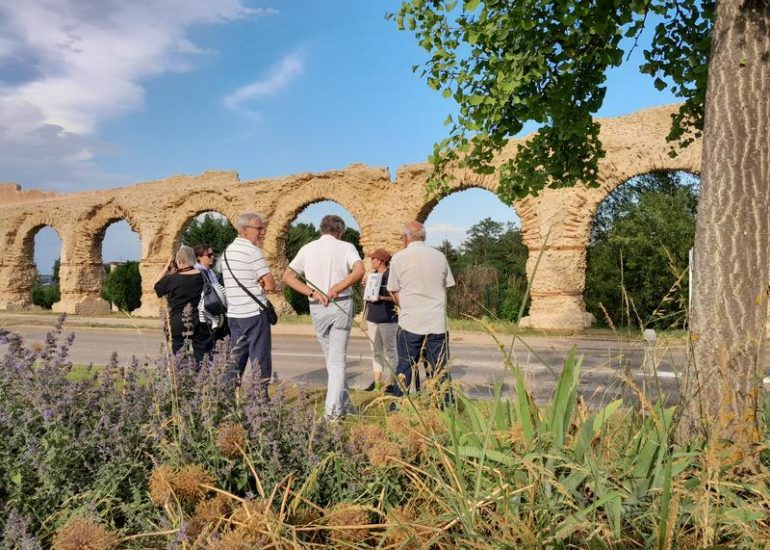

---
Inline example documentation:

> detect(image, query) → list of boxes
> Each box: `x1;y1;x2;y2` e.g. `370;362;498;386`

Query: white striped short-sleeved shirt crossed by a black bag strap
222;237;270;319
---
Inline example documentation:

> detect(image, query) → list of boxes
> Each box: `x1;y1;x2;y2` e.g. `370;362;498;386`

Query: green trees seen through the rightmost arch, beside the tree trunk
585;172;698;328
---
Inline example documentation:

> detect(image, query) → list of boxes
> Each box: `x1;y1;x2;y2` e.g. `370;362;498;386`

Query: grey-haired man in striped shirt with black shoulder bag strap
222;212;275;398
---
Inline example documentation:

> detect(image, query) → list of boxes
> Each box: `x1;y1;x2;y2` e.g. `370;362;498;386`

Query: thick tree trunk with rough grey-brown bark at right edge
679;0;770;447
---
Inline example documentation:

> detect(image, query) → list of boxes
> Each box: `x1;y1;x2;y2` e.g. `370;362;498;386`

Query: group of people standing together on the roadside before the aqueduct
155;213;454;419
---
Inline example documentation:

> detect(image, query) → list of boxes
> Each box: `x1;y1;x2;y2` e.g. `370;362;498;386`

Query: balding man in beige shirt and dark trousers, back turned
388;221;455;396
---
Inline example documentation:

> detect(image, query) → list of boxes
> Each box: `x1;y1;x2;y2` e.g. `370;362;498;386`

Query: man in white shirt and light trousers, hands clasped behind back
282;215;365;419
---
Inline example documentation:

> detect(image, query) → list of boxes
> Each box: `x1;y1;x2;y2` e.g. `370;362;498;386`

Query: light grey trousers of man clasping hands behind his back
310;300;353;418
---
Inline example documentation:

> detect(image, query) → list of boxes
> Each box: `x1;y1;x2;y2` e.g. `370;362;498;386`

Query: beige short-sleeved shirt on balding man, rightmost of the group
388;241;455;334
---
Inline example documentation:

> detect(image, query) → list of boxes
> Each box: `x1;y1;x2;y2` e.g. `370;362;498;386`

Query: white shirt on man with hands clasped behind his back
289;235;361;296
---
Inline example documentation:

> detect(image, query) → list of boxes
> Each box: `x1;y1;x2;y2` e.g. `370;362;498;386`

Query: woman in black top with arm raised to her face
155;245;211;363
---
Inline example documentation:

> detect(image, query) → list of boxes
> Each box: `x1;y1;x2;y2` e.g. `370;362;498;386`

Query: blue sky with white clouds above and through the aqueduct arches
0;0;674;272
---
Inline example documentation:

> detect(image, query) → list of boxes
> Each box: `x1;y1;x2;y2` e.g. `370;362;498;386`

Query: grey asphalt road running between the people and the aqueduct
0;317;685;402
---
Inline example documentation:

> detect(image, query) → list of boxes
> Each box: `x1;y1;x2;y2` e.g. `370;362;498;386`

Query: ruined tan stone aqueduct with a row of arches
0;106;701;329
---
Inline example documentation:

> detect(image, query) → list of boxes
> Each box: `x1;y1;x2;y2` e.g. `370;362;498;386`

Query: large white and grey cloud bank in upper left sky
0;0;277;190
